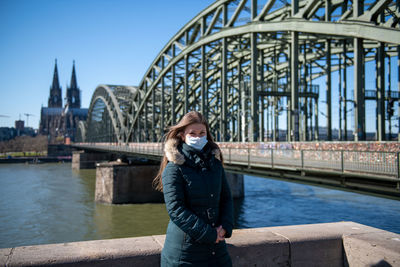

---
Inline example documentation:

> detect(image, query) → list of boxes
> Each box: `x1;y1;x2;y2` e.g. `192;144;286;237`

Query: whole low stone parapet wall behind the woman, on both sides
0;222;400;267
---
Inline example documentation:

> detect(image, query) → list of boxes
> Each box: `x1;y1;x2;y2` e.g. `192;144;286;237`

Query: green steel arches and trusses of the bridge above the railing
78;0;400;143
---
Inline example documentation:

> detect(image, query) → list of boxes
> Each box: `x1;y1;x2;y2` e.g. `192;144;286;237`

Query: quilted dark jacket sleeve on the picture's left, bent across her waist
162;162;217;243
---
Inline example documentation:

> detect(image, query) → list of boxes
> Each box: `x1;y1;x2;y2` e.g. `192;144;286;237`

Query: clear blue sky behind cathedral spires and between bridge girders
0;0;397;135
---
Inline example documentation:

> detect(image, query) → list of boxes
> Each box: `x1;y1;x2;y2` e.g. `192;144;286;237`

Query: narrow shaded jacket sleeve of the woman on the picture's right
220;169;233;238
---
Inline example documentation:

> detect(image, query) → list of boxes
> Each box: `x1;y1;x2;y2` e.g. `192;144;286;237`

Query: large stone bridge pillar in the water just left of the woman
95;162;163;204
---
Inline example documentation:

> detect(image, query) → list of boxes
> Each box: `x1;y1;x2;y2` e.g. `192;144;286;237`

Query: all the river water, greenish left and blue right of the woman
0;163;400;248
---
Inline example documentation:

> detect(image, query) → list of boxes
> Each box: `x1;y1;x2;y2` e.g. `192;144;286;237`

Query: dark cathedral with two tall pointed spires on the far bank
39;60;88;142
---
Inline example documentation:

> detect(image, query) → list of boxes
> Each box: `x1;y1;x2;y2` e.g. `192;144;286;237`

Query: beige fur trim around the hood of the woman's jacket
164;138;221;165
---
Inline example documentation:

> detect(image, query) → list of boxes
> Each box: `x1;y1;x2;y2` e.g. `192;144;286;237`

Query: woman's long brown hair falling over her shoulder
153;111;223;192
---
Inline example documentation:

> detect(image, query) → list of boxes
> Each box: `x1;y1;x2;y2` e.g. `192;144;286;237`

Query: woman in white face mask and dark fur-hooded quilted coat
154;111;233;267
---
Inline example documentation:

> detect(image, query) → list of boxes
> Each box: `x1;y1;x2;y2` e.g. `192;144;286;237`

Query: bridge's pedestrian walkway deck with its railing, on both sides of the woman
73;142;400;198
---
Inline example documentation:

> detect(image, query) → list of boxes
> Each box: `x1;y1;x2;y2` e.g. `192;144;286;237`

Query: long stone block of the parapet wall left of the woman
8;236;161;266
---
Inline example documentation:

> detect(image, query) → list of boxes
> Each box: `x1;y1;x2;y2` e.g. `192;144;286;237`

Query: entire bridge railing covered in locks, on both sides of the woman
75;143;400;181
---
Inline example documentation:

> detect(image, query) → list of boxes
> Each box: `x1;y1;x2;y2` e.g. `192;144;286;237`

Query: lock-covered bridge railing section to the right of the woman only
221;148;400;179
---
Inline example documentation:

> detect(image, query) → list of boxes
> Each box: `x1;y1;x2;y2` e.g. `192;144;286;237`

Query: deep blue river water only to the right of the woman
234;176;400;233
